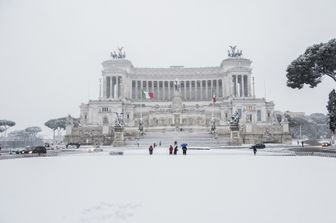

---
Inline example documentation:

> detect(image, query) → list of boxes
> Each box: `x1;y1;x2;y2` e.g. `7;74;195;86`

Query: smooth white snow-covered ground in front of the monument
0;149;336;223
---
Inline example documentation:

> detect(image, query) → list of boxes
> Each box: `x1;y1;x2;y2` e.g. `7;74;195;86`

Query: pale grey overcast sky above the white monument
0;0;336;135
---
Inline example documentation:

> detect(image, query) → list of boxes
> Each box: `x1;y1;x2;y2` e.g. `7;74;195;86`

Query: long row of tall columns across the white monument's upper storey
103;75;251;101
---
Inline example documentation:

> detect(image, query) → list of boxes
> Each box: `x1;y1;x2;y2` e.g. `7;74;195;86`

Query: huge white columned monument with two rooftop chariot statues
66;47;290;144
